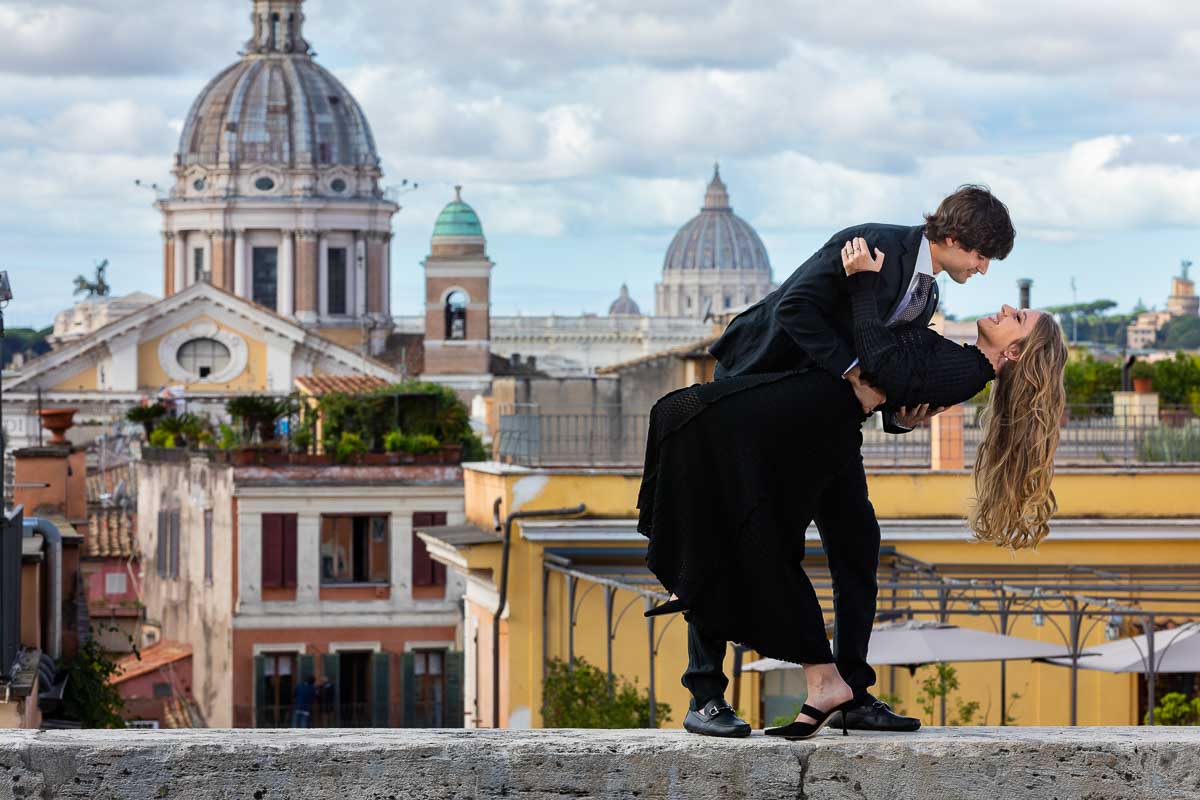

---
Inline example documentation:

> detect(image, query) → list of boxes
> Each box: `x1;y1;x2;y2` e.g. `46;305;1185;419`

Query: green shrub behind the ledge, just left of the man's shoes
542;658;671;728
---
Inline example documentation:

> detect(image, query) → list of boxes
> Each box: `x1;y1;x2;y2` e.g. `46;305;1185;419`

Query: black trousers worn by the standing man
683;453;880;708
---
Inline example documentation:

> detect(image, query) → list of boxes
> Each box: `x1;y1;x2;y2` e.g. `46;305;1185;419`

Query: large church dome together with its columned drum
156;0;400;340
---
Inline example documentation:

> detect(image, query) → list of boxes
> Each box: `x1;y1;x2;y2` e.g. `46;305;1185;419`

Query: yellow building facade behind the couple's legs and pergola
421;463;1200;727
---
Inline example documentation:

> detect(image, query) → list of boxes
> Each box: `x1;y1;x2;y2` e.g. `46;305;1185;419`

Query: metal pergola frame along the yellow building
541;546;1200;726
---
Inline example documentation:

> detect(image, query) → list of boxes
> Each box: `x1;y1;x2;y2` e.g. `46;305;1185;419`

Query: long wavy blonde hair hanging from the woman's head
970;314;1067;549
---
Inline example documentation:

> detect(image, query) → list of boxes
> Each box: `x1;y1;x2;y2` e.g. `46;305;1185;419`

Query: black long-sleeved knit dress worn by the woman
637;272;995;663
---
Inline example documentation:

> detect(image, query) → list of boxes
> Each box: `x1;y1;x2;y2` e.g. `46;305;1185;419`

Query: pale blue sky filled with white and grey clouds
0;0;1200;325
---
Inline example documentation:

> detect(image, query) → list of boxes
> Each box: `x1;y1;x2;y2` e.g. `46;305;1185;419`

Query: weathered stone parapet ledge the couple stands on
0;727;1200;800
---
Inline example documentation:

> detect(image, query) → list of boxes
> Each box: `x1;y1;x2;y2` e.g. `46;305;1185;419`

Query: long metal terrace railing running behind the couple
496;404;1200;468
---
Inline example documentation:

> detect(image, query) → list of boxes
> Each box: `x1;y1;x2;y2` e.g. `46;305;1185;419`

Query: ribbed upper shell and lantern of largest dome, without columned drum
176;0;379;197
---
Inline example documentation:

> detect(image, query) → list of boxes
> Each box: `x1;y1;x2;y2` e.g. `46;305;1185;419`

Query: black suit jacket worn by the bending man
709;224;936;378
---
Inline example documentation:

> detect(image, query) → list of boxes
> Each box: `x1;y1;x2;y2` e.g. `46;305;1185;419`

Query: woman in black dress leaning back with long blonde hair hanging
637;241;1067;738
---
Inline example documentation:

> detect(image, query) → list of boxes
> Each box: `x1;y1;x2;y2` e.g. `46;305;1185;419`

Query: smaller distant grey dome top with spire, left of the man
662;167;770;273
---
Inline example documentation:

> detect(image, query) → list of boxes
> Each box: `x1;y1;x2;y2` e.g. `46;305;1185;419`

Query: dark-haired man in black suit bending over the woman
683;186;1015;736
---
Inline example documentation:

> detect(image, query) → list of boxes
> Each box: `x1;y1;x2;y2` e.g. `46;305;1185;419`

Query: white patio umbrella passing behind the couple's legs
742;620;1080;672
